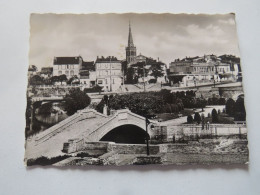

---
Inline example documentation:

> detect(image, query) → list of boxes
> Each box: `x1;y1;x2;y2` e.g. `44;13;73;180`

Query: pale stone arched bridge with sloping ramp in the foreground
26;109;157;158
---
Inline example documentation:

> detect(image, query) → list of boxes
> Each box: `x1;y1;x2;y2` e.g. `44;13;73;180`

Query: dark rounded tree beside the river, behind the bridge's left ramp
64;88;91;115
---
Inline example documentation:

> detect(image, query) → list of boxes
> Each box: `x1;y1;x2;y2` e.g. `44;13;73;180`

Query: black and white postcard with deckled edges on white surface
24;13;249;166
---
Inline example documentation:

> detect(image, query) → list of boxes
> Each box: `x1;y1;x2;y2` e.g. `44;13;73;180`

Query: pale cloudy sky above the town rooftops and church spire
29;13;240;68
